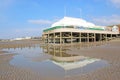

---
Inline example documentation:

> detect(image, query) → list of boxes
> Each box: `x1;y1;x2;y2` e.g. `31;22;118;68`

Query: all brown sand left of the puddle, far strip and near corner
0;40;42;80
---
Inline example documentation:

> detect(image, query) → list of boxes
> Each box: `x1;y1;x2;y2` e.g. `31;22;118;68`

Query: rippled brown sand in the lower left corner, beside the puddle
0;51;41;80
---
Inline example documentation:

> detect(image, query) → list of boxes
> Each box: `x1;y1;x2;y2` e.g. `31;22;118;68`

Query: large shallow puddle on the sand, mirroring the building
3;45;109;80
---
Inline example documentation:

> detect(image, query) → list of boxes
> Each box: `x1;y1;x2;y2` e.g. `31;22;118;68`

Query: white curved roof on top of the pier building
52;17;95;27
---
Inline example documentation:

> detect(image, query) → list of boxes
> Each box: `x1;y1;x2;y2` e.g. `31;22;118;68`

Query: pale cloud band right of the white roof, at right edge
92;15;120;26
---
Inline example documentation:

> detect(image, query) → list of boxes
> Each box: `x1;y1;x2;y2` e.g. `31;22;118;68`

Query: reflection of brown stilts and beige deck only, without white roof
44;46;79;62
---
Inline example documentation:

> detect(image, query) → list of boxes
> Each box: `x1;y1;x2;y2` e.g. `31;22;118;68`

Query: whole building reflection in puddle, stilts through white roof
41;46;100;70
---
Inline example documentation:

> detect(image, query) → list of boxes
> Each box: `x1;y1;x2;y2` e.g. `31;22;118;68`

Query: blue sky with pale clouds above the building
0;0;120;39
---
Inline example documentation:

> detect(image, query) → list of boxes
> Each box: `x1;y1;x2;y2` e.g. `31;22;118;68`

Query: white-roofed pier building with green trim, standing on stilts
43;17;118;44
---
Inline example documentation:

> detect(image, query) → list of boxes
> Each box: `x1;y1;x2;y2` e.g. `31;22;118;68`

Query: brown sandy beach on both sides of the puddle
0;39;120;80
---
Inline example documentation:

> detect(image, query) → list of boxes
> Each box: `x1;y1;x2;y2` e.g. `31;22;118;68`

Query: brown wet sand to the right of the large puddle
66;40;120;80
